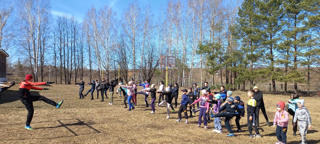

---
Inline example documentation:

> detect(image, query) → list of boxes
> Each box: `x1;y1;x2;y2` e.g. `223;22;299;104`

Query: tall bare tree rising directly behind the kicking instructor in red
19;0;50;81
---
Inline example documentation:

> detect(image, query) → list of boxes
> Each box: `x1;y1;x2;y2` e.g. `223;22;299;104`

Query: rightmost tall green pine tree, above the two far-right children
283;0;316;90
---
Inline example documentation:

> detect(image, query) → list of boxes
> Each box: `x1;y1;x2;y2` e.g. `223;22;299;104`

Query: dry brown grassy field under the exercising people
0;85;320;144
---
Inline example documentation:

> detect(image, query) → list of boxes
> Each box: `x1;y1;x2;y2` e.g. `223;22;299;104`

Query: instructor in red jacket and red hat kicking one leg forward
19;74;63;130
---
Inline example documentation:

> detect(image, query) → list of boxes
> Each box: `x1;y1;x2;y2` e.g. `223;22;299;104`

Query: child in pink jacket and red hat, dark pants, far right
273;101;289;144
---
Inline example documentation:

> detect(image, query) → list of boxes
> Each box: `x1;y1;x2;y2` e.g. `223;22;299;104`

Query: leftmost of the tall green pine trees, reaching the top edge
237;0;264;86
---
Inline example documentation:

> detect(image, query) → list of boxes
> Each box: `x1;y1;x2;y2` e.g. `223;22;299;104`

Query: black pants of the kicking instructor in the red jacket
20;96;57;126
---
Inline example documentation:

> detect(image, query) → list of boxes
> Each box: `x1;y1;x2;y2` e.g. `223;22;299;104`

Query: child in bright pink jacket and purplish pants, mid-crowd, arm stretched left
190;90;209;129
